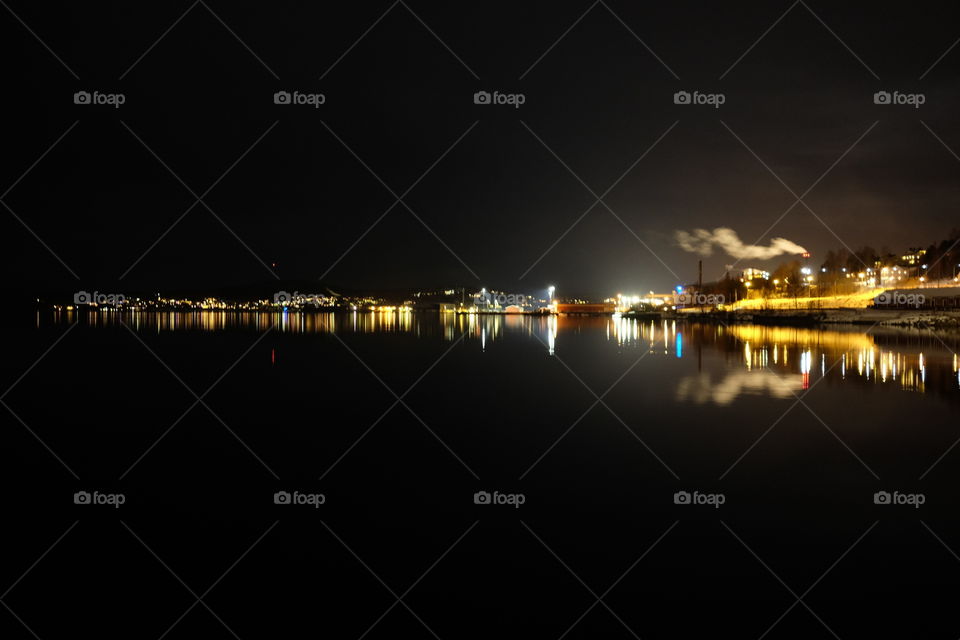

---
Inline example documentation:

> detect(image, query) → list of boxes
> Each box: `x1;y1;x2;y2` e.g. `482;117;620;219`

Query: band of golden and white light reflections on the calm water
55;311;960;405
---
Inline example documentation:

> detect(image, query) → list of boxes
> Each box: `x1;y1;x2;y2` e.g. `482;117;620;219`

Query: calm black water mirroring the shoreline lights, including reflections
0;312;960;640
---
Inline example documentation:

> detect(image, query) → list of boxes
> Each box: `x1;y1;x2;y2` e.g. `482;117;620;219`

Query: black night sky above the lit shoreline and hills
0;0;960;296
